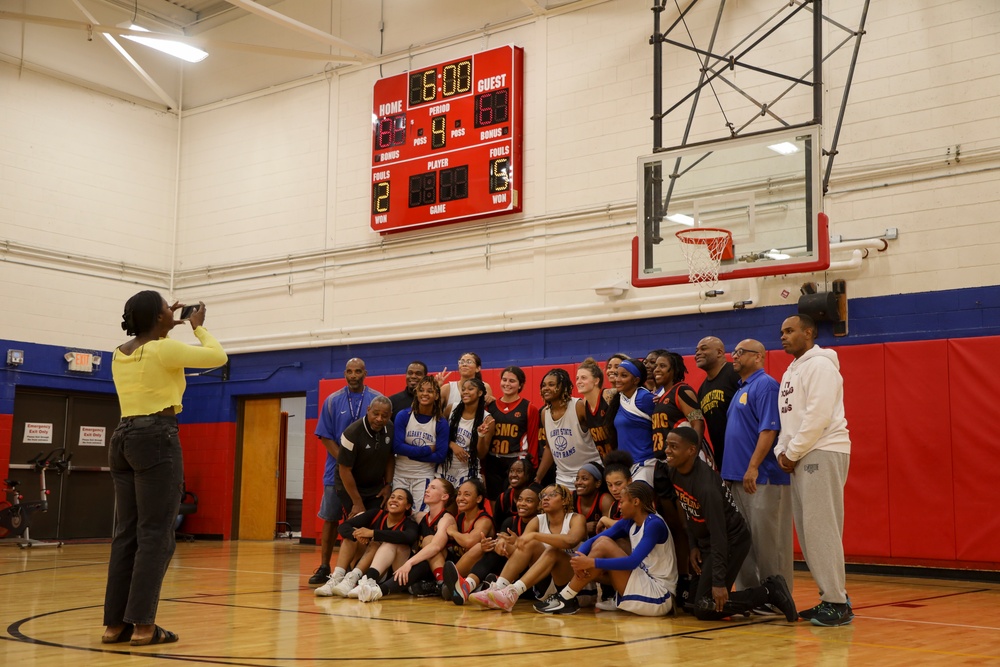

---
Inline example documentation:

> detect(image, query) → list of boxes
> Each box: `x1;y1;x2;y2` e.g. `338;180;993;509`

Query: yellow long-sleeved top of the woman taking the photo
111;327;229;417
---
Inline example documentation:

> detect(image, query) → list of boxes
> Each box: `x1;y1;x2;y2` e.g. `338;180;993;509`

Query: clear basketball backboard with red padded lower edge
632;125;830;287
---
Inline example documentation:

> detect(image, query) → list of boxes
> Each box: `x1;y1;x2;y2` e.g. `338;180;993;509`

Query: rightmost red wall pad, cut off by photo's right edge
944;337;1000;565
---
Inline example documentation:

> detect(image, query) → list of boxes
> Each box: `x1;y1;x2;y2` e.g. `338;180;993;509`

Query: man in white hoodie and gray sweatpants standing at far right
774;315;854;626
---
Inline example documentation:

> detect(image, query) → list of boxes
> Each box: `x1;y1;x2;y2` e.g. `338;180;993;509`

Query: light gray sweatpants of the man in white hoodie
792;449;851;604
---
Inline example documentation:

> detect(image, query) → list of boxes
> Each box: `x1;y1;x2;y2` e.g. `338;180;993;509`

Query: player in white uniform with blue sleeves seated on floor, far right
535;482;677;616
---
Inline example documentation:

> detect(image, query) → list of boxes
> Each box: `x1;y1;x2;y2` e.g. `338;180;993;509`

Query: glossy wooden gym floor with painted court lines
0;541;1000;667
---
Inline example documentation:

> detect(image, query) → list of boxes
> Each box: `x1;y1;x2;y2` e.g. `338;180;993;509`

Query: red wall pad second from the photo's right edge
888;340;956;560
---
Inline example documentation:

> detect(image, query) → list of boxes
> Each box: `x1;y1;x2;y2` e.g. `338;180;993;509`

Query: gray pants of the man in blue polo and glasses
727;481;793;591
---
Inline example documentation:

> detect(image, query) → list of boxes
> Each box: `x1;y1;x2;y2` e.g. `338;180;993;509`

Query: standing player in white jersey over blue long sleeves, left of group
392;377;448;511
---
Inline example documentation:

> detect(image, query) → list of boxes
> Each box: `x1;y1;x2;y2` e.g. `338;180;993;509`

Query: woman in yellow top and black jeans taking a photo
101;290;227;646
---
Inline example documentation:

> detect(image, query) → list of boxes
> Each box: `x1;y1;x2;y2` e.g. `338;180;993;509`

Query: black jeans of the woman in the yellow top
104;415;184;626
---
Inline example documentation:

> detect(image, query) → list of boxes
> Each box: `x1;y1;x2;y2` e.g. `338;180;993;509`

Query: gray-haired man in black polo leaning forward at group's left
333;396;395;516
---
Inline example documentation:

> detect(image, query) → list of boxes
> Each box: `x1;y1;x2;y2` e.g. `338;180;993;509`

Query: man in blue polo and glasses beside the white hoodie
722;339;792;589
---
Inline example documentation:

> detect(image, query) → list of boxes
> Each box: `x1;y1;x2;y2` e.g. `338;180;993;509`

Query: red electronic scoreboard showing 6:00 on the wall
371;46;524;233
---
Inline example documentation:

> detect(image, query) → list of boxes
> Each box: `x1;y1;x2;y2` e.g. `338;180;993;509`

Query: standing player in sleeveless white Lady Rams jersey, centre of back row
535;368;601;488
